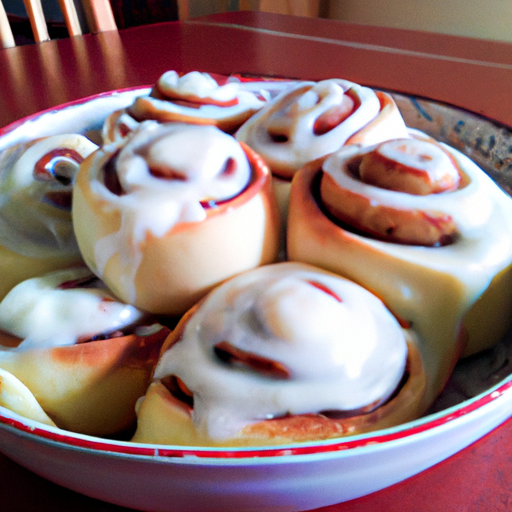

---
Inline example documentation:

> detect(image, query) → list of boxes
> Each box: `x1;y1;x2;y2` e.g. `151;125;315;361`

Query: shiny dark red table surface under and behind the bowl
0;12;512;512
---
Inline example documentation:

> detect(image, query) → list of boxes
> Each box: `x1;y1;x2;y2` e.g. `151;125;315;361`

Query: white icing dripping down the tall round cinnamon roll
84;121;251;302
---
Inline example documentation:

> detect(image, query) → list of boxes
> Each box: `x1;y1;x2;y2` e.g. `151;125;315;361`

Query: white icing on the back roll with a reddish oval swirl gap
236;79;380;177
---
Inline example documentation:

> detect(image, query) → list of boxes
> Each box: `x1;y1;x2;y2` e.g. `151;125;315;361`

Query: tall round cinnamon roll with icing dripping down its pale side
73;121;279;315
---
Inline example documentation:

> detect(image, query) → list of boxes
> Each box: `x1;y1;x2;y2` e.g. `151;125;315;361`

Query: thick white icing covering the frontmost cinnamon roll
155;263;407;438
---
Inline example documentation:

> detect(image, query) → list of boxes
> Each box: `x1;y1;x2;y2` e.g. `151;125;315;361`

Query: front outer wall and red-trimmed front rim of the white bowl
0;368;512;512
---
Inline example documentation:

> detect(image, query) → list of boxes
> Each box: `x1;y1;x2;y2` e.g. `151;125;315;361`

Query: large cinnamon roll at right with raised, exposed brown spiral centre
288;138;512;408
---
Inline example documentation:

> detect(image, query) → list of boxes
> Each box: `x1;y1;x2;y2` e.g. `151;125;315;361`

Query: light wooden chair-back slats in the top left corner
0;0;117;48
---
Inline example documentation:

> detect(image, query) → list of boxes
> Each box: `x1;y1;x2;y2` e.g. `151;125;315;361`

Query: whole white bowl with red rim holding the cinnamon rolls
0;80;512;512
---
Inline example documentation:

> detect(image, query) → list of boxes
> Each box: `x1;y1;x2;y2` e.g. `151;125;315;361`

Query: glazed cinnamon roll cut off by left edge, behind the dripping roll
0;134;97;300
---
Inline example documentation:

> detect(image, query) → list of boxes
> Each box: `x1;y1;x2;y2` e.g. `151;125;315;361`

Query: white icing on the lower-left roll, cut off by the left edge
0;268;143;350
